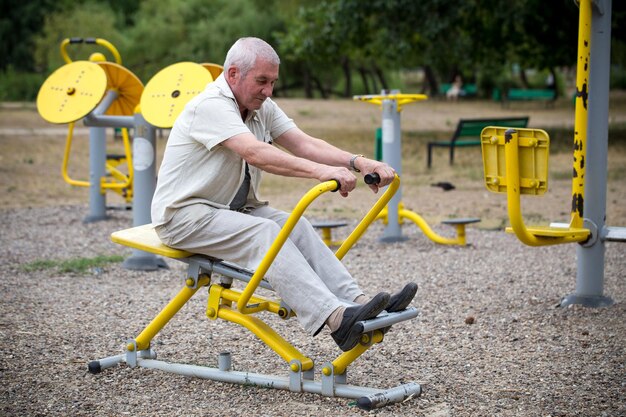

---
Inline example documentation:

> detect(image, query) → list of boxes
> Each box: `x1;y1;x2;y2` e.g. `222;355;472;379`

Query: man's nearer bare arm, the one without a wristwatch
222;133;356;197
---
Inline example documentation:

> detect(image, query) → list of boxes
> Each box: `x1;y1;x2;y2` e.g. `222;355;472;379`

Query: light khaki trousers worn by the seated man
156;204;363;334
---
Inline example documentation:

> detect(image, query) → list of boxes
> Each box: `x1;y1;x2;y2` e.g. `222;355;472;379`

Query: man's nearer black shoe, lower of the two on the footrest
330;292;388;352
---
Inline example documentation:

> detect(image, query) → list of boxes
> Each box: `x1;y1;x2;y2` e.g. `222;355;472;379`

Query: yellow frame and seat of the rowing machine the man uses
117;176;400;375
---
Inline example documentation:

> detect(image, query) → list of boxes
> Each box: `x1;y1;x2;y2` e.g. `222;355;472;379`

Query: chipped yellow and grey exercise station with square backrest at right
481;0;626;307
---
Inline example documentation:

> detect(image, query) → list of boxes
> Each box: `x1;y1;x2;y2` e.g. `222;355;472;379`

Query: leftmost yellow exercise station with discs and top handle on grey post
37;38;143;222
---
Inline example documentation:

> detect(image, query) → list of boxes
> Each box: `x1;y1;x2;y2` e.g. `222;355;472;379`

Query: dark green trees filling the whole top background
0;0;626;99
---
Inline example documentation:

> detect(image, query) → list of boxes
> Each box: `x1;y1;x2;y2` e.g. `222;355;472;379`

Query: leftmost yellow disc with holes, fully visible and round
37;61;106;123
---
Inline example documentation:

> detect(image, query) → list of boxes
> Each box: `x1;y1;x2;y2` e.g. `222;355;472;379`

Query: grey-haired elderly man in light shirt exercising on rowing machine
152;38;417;351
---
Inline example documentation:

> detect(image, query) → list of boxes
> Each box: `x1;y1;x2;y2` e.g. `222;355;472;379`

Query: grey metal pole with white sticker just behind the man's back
122;113;167;271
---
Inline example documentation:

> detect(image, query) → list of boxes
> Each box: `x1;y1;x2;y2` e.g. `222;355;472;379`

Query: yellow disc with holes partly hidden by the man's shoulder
141;62;213;129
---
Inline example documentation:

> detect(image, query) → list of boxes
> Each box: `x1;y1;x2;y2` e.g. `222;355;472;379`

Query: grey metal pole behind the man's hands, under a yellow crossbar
380;92;408;242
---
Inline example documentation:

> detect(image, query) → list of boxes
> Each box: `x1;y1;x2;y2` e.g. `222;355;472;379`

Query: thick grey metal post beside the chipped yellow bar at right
561;0;613;307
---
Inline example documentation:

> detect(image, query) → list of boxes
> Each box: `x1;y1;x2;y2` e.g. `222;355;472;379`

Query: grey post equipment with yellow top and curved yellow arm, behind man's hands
354;91;480;246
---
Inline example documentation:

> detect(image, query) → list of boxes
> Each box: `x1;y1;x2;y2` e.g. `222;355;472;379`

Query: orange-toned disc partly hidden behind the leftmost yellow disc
98;62;143;116
